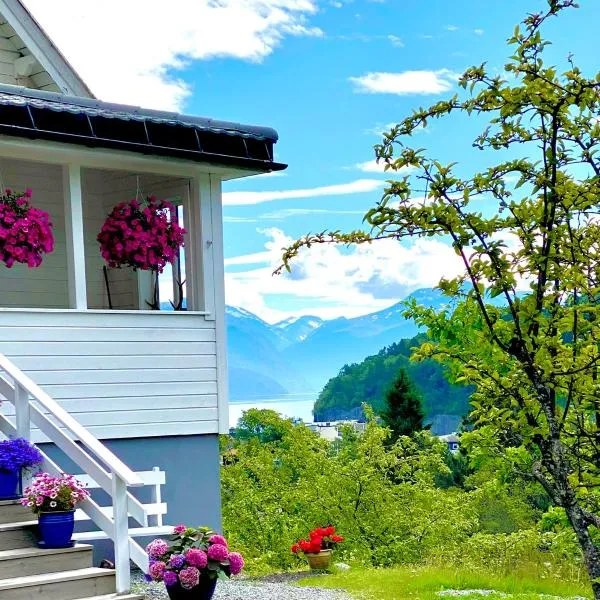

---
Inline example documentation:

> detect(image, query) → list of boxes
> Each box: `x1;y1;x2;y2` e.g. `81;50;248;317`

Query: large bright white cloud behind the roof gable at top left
25;0;323;110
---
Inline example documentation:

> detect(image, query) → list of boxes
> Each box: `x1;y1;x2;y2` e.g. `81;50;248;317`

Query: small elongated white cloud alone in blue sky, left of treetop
350;69;458;96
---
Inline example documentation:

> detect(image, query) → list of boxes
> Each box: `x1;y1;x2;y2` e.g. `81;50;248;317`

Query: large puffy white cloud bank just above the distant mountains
225;228;462;322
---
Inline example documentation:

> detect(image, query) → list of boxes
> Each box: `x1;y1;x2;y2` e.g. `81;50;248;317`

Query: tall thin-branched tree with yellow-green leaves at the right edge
283;0;600;599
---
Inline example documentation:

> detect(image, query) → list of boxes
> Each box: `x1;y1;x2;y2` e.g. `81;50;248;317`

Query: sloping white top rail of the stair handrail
0;354;144;487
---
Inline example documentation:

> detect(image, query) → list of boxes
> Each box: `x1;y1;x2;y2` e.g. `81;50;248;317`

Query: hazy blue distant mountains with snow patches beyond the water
226;289;448;401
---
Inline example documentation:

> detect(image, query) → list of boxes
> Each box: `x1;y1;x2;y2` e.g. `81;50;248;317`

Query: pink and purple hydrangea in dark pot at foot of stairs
146;525;244;600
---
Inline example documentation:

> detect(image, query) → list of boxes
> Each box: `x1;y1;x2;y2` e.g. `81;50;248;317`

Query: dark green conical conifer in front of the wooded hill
381;369;425;442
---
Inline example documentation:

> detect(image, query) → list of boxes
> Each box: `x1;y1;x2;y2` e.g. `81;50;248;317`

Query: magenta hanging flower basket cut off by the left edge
0;188;54;268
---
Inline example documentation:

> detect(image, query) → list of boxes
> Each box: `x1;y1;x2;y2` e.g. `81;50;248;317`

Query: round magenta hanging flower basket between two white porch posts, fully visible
97;196;186;273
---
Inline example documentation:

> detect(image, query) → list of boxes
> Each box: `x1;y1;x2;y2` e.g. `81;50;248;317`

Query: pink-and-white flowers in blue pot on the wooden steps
21;473;90;548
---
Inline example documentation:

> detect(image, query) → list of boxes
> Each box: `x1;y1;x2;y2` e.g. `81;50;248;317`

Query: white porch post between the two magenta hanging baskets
63;164;87;310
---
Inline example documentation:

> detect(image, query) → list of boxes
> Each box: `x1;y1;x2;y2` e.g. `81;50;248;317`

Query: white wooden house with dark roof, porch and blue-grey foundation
0;0;285;600
